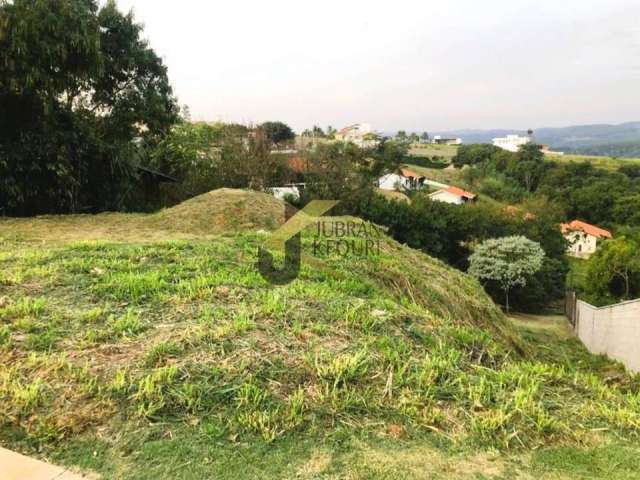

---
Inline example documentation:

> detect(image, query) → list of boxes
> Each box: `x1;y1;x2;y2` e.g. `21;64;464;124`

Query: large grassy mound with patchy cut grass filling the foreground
0;190;640;479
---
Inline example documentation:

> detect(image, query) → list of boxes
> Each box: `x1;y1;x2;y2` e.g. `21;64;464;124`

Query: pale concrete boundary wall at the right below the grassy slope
574;299;640;372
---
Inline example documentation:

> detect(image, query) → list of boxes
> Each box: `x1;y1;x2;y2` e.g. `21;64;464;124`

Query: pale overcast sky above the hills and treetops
112;0;640;131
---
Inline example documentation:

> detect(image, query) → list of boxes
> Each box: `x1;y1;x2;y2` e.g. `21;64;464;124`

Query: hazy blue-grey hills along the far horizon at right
402;122;640;157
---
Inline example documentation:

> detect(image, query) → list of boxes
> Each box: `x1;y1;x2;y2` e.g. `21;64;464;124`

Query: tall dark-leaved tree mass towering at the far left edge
0;0;179;215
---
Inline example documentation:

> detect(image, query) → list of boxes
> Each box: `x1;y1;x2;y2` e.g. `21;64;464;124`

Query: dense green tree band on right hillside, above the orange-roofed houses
453;144;640;228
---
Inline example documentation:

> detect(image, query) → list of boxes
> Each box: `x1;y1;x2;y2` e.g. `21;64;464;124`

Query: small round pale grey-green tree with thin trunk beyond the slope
469;236;545;312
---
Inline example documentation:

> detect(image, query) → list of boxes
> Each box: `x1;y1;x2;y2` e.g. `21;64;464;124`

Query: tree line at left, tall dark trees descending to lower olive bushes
0;0;294;216
